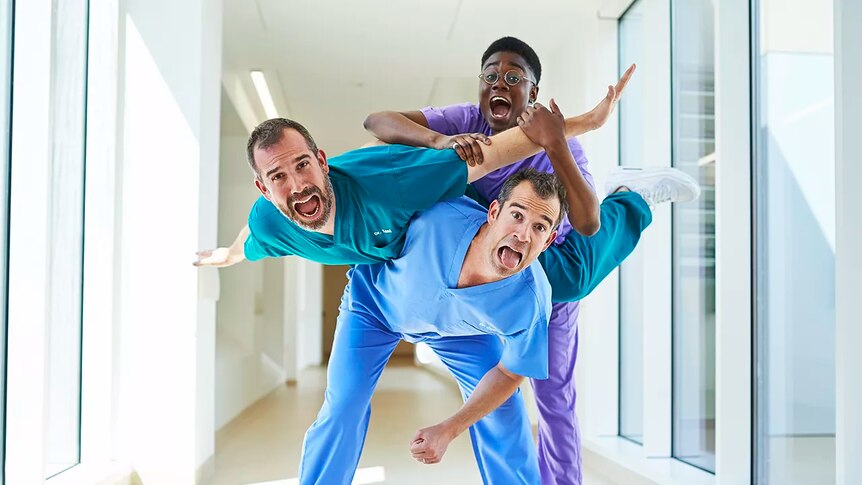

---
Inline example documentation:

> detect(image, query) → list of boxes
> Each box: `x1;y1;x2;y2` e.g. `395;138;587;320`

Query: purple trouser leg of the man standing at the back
530;303;581;485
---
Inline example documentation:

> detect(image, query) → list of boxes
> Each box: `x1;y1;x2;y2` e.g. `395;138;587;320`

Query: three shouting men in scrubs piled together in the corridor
195;37;700;485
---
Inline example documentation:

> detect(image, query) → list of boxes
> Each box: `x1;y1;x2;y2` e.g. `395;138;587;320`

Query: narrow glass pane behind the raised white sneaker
619;1;649;444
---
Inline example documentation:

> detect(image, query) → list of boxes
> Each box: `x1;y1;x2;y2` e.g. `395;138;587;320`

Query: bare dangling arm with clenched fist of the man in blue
410;363;524;465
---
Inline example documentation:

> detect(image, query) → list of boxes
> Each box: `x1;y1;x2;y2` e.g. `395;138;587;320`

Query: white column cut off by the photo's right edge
834;0;862;485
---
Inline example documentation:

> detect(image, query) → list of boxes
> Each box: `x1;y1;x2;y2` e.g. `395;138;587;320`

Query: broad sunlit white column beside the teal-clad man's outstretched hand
119;0;222;483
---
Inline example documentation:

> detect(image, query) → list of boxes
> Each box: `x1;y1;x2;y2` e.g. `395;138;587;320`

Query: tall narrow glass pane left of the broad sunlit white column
45;0;88;477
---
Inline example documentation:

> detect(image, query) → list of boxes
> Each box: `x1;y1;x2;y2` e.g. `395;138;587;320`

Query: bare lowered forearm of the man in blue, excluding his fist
444;365;524;436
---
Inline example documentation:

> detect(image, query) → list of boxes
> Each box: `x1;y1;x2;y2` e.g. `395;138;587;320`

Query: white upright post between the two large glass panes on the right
715;0;752;484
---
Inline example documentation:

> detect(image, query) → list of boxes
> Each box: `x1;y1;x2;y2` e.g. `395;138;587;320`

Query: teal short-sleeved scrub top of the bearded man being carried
245;145;467;264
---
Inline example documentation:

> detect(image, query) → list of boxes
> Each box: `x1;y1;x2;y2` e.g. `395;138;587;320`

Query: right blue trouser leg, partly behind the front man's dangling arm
427;335;540;485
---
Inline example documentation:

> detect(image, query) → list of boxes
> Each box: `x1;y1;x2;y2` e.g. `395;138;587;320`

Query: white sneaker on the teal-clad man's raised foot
605;167;700;207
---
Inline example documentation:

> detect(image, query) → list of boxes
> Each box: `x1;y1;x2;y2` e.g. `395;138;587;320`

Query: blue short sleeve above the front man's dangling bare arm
500;314;548;379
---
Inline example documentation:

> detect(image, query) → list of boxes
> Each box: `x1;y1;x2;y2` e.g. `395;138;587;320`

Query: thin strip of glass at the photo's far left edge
0;0;12;485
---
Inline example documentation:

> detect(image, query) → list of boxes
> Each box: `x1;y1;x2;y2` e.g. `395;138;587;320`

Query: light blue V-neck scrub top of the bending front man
342;197;551;379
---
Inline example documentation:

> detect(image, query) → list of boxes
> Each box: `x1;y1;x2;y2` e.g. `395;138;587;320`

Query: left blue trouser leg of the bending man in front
299;308;400;485
